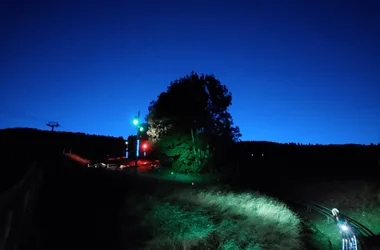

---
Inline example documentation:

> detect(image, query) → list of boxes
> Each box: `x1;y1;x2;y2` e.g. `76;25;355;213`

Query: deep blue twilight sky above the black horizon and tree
0;0;380;144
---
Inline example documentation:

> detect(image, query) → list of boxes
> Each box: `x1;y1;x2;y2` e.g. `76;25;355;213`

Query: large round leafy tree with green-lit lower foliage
147;72;241;172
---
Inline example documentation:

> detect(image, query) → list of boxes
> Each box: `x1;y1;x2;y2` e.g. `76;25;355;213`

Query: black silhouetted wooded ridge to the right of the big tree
227;141;380;186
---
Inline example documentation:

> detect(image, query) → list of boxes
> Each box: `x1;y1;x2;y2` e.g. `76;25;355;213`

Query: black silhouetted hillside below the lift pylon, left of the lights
0;128;125;190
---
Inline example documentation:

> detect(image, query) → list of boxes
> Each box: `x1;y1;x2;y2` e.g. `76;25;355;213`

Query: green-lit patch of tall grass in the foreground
135;189;302;250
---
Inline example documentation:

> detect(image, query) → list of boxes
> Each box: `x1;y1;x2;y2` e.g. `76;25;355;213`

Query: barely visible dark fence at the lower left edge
0;163;43;250
